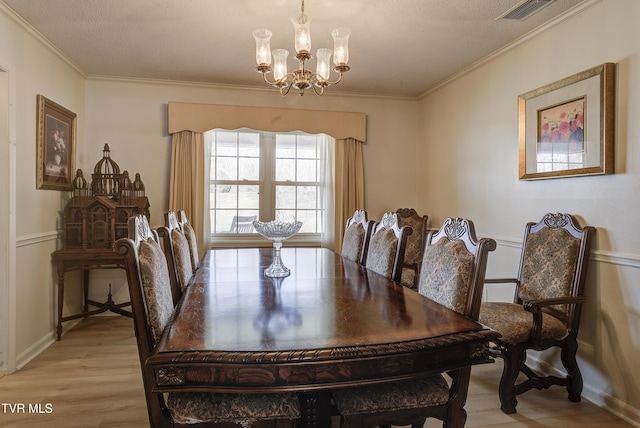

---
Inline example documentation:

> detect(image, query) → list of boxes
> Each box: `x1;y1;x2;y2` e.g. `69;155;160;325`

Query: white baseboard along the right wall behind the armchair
527;354;640;427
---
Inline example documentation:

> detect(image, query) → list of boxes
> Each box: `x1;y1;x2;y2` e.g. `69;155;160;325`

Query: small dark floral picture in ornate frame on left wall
36;95;76;190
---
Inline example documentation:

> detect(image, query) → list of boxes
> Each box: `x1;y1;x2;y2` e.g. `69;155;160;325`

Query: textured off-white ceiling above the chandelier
3;0;588;97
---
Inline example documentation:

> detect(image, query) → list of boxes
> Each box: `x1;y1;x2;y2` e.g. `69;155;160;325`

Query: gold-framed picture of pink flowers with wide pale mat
518;63;615;180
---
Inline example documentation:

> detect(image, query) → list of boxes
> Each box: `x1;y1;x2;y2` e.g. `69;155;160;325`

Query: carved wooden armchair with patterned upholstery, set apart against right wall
480;213;595;414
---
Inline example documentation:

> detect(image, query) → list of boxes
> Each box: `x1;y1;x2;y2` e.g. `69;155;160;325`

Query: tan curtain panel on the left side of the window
169;131;211;254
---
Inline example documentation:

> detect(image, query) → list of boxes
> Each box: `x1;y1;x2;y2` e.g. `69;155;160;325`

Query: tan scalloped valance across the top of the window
168;102;367;142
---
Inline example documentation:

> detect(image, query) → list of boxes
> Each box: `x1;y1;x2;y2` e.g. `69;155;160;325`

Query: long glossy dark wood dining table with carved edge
145;247;498;426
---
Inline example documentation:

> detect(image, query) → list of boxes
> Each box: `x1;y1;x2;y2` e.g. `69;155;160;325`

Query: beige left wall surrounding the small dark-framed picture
0;3;85;371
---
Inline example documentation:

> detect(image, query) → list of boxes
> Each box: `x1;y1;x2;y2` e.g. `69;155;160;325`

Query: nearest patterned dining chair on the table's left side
114;216;300;428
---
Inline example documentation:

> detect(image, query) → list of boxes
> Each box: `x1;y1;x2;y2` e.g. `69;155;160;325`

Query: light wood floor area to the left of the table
0;316;149;428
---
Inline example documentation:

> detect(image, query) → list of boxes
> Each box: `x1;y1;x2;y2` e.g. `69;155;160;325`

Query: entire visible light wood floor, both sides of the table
0;316;632;428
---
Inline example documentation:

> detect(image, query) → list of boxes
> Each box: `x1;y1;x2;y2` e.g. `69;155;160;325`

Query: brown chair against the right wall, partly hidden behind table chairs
396;208;429;289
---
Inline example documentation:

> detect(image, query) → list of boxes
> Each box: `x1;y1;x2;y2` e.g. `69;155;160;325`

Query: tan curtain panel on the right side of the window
333;138;364;254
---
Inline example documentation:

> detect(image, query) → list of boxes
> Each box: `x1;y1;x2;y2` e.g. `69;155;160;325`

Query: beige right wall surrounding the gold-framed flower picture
417;0;640;423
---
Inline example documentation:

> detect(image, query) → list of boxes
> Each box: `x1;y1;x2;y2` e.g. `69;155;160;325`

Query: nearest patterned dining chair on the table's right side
333;218;496;428
